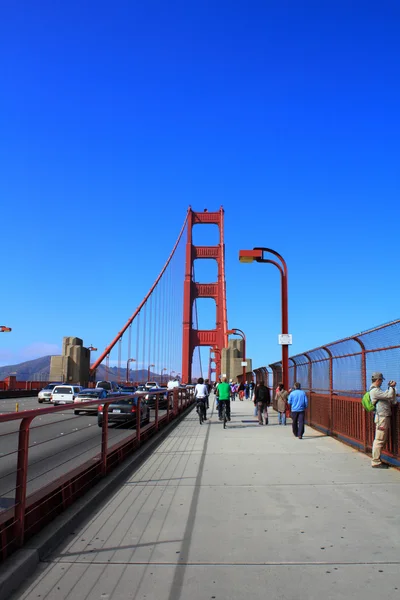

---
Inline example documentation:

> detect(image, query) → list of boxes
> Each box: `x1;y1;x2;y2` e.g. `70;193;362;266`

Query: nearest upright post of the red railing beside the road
14;417;33;546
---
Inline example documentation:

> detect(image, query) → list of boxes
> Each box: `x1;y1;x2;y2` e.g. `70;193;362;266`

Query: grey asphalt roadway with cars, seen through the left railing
0;398;170;509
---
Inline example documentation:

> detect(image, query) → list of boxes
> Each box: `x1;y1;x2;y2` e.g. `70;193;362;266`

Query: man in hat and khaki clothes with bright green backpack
369;371;397;469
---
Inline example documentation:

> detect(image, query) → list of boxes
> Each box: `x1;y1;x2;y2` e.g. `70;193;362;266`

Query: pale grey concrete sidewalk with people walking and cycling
9;401;400;600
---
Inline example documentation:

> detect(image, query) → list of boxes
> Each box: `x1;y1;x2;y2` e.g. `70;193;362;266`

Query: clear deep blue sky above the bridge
0;0;400;376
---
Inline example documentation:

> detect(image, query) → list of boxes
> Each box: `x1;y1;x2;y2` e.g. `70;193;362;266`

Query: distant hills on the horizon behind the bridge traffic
0;356;160;381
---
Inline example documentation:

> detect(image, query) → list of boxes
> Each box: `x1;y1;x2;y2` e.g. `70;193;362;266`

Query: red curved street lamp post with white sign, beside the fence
239;247;292;390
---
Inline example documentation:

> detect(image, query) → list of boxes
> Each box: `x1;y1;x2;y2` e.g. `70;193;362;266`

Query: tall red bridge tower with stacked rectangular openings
182;207;228;383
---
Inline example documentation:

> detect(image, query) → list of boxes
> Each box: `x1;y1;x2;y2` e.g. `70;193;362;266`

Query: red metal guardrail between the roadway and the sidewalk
0;388;193;560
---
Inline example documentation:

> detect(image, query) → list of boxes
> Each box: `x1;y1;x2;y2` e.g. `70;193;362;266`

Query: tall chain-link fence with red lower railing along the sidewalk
254;319;400;465
